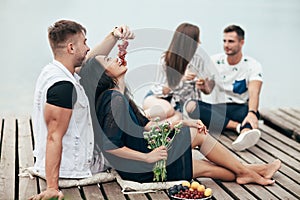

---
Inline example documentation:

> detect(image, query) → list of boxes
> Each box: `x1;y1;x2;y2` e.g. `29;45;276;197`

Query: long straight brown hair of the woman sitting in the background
165;23;200;88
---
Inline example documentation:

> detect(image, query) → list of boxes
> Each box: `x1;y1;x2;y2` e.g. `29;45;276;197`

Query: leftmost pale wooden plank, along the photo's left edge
0;117;16;199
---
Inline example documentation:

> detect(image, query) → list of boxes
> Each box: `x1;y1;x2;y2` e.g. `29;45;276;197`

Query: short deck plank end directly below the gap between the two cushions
102;182;126;200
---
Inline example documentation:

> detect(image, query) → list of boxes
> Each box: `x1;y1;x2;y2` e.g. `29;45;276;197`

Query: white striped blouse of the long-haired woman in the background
151;46;216;105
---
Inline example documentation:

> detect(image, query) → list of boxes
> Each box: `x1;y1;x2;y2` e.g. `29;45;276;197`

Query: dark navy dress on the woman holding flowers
95;90;192;182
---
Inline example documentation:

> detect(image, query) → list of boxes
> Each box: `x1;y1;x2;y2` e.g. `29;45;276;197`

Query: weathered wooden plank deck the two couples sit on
0;108;300;200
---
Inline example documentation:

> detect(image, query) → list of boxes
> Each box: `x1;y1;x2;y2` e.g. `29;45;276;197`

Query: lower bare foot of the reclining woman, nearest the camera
236;170;275;185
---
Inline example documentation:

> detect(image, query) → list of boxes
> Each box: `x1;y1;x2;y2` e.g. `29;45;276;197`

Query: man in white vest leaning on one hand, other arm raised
32;20;134;199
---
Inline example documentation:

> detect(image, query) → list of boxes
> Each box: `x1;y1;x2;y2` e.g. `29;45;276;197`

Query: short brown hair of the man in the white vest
48;20;86;51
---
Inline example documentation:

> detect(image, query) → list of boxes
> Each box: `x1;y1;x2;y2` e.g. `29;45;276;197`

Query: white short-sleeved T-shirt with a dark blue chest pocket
212;53;263;104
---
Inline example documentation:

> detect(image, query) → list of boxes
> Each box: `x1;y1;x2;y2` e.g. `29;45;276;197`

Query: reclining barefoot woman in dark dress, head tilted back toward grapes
83;55;281;185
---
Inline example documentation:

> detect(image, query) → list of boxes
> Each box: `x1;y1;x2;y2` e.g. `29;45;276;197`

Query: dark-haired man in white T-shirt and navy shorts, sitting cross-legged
186;25;262;151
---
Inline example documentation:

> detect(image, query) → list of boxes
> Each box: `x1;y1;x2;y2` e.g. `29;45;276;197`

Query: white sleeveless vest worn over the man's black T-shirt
32;60;94;178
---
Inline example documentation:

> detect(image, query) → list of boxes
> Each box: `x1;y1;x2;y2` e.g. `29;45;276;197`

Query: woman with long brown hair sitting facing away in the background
143;23;214;122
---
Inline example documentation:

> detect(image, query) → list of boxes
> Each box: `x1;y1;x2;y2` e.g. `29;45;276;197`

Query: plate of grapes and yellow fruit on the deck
168;181;212;200
